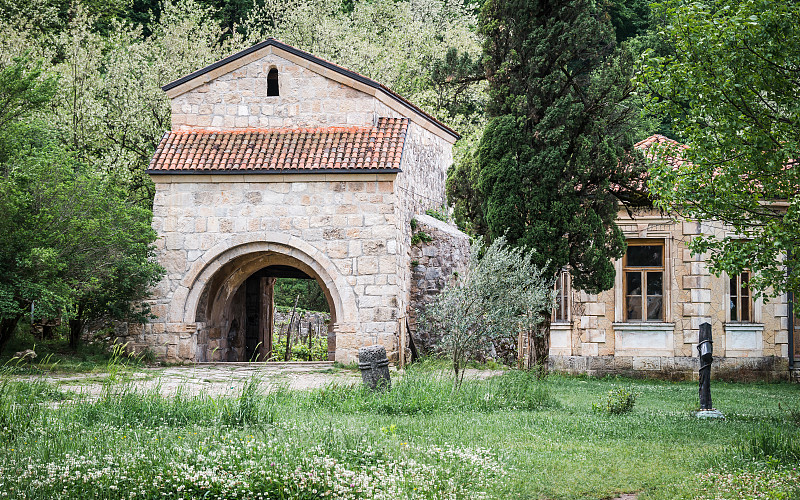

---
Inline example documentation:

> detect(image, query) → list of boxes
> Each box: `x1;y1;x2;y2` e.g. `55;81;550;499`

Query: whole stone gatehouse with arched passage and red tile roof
128;39;468;363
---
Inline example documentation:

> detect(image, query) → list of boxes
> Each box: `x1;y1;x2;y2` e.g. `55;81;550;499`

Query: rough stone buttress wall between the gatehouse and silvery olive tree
408;214;470;352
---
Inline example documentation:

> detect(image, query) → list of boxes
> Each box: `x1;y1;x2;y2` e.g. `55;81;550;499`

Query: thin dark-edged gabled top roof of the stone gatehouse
161;38;461;142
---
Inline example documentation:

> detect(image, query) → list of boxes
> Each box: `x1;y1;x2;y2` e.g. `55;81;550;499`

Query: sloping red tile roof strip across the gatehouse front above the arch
147;118;408;174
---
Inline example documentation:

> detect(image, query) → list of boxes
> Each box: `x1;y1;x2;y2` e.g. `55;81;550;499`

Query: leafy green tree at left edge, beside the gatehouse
0;61;163;350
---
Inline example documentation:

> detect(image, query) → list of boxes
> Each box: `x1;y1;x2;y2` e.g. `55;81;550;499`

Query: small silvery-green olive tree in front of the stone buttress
420;237;554;385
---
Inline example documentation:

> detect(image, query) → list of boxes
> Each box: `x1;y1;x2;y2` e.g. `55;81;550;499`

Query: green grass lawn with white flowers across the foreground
0;365;800;499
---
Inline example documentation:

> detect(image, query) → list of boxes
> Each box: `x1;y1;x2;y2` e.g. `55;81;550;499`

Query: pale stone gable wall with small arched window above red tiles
172;48;400;130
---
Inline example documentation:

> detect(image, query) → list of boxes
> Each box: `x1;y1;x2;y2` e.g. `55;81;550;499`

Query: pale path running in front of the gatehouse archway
39;362;502;397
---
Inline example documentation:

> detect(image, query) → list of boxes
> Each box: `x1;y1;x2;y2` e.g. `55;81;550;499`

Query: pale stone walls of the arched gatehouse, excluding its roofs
141;43;454;362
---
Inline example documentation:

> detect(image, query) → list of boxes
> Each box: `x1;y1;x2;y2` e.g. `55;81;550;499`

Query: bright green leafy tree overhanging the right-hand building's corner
639;0;800;300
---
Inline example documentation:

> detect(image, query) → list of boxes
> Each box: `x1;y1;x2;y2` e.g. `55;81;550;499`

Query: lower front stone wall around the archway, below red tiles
128;174;401;363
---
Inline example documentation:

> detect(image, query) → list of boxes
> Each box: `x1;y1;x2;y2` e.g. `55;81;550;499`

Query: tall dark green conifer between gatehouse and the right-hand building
451;0;638;365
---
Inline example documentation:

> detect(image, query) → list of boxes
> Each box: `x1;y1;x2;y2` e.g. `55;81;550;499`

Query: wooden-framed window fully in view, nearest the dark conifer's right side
622;240;664;322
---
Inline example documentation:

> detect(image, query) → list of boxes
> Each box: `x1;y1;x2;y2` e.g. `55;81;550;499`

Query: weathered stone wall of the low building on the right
551;205;788;378
